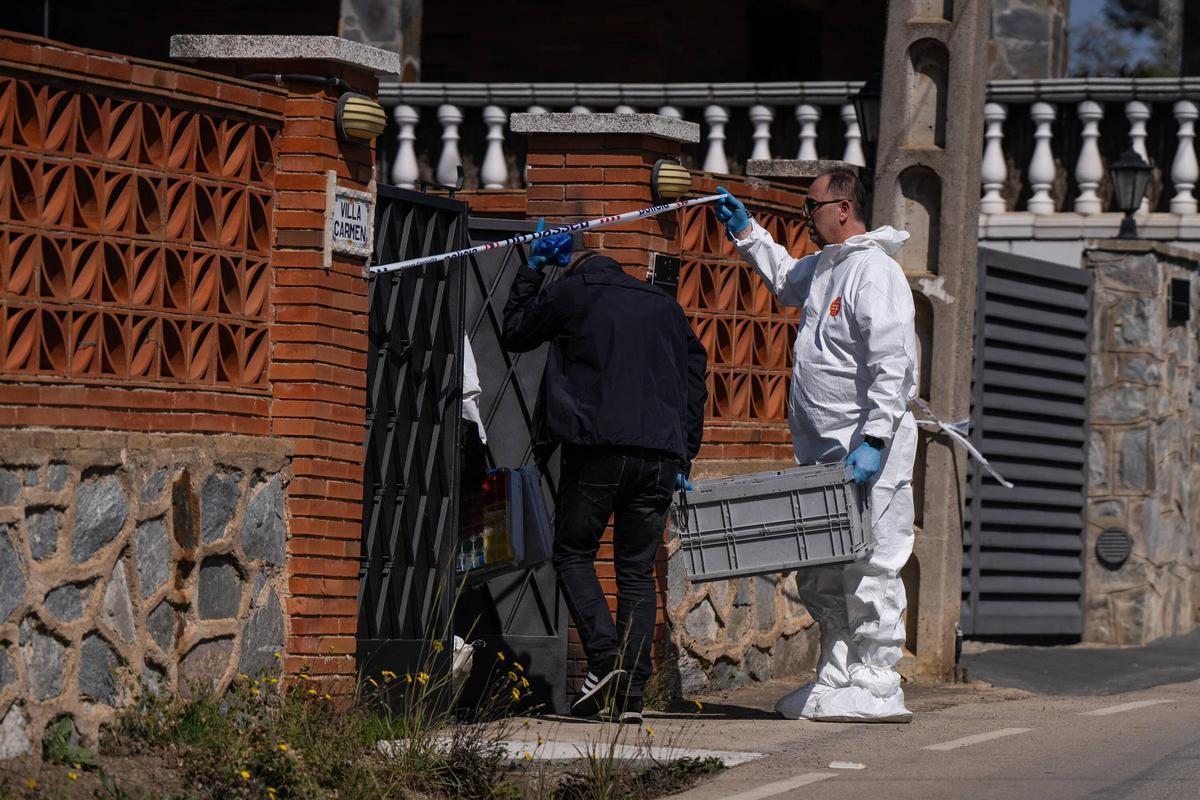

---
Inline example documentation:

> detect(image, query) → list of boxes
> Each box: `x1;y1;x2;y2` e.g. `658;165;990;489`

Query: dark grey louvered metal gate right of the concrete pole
961;249;1092;636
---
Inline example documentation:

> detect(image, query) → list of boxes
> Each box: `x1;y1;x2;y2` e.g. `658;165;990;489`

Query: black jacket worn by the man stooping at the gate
503;255;708;473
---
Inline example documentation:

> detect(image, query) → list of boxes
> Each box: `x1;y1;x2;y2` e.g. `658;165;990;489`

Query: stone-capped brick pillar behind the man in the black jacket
510;114;700;685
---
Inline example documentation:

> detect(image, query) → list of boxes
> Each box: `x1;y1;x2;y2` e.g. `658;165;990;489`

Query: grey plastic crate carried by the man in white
676;463;875;583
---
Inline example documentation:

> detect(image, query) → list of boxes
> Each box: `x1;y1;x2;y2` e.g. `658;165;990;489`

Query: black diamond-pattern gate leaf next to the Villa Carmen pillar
358;186;467;674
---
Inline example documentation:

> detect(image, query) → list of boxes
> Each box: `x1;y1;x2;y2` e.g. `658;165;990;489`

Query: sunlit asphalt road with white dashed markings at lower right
678;681;1200;800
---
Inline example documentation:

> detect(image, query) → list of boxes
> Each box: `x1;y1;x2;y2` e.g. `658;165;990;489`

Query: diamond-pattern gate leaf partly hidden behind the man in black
455;218;568;712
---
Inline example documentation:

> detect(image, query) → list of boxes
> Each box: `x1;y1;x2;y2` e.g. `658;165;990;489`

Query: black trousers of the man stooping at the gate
554;446;679;696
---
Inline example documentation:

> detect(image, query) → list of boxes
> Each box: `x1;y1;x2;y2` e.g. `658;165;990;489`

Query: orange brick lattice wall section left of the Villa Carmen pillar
0;36;284;435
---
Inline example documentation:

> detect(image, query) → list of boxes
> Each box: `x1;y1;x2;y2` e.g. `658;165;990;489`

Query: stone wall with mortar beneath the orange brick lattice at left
0;431;290;758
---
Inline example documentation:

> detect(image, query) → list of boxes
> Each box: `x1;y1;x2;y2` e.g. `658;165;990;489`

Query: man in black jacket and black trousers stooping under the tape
504;221;708;722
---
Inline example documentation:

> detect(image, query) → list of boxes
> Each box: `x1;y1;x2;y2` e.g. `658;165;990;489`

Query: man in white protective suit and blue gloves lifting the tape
715;169;917;722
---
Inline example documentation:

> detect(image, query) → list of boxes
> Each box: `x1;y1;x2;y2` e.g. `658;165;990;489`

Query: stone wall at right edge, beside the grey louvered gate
1084;242;1200;644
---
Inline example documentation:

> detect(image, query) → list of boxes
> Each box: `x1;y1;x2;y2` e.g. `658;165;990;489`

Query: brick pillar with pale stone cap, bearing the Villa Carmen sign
172;36;400;688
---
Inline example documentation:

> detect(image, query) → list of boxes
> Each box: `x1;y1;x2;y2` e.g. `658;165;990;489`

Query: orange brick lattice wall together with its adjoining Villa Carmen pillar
0;34;376;700
